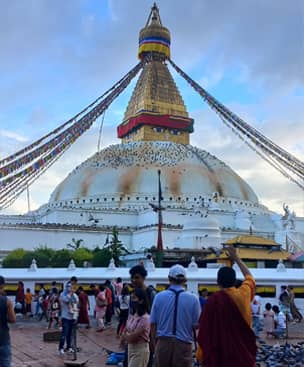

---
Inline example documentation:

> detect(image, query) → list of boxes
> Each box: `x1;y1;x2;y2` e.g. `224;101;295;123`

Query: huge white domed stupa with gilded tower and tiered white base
0;5;303;262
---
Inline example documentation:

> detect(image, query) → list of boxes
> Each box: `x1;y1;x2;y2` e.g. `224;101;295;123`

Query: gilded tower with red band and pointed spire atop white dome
117;4;193;144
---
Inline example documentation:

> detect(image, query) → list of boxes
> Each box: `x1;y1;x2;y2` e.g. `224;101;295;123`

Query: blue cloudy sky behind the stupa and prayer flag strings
0;0;304;216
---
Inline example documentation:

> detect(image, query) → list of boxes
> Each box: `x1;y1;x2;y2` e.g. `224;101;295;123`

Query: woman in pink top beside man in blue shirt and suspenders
121;288;150;367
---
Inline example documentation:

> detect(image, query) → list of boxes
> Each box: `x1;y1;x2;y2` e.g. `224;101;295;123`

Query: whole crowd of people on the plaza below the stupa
0;247;302;367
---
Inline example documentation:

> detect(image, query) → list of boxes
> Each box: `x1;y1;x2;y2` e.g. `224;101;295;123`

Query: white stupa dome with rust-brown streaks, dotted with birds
49;141;258;206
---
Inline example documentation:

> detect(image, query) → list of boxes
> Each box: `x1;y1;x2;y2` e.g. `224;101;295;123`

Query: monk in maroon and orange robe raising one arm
198;247;257;367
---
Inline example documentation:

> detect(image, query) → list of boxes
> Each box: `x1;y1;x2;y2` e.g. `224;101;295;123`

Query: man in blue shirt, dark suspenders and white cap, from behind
150;265;201;367
